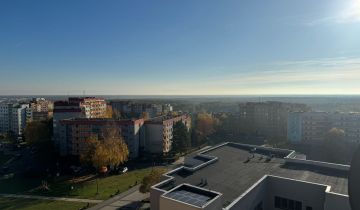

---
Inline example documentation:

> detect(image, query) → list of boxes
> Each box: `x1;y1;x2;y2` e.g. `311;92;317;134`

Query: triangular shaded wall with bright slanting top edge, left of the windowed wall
225;176;267;210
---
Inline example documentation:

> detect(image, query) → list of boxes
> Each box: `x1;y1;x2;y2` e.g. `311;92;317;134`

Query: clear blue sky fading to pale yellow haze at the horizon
0;0;360;95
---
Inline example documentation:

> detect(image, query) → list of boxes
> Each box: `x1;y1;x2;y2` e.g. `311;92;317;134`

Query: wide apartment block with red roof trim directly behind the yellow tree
60;118;144;158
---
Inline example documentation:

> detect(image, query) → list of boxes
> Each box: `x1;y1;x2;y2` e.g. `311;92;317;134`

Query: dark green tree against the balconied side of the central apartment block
172;121;191;152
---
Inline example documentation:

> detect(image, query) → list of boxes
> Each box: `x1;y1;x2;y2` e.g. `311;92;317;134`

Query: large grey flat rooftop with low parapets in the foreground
164;143;348;205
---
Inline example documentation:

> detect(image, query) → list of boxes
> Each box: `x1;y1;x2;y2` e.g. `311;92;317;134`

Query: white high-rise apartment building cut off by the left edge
0;102;29;136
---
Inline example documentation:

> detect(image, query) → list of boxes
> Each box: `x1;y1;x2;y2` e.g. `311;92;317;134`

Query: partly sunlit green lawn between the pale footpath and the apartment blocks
0;168;165;200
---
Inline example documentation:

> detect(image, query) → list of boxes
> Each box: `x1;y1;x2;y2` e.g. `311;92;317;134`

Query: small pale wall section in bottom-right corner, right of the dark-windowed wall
324;192;351;210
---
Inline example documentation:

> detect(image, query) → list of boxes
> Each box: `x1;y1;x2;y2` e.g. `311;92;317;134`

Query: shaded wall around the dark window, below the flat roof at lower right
264;176;328;210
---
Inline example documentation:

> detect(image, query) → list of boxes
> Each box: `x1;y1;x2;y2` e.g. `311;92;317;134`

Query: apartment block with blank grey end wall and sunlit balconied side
145;115;191;153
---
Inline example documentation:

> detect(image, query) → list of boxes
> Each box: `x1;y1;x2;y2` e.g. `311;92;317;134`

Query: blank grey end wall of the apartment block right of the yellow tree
145;124;163;153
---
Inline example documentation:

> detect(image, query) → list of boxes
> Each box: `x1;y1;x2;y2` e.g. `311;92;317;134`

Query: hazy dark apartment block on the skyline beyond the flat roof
239;101;309;139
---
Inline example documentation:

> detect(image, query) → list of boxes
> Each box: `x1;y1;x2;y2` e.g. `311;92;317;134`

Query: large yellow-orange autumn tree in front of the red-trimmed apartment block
80;125;129;169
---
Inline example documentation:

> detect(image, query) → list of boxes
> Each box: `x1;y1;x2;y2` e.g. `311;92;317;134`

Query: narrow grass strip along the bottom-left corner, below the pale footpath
0;198;91;210
